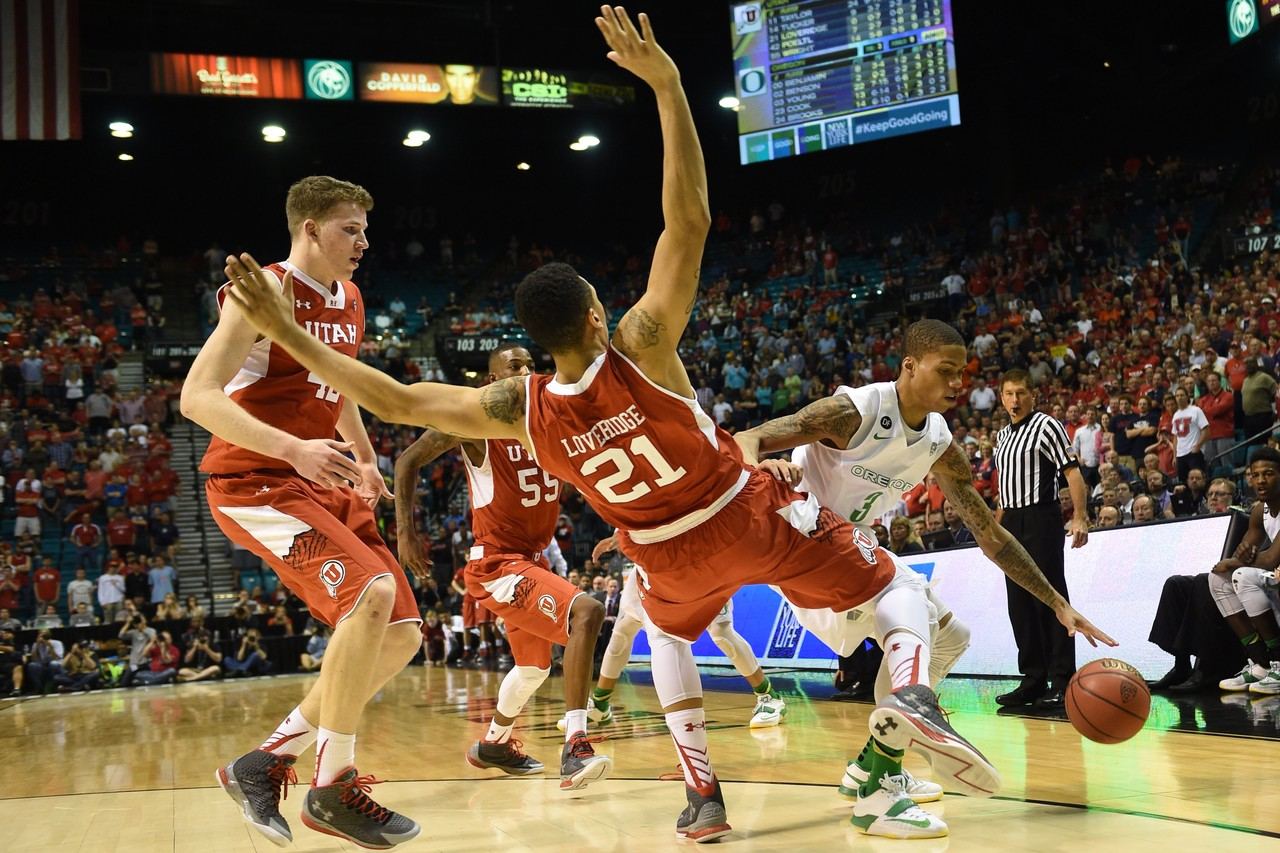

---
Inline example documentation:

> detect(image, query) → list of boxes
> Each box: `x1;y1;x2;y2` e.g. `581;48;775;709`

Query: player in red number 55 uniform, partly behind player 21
396;346;612;790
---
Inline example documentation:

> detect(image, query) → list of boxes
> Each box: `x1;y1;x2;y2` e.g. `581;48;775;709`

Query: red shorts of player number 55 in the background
465;546;582;670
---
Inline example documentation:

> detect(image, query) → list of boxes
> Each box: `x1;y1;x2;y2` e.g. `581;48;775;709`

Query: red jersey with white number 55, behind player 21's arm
462;438;559;555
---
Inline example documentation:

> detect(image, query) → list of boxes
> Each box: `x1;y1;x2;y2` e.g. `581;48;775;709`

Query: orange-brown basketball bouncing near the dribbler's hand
1066;657;1151;743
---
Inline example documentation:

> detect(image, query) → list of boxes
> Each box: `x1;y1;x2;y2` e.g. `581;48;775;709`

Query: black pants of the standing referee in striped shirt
1001;501;1075;688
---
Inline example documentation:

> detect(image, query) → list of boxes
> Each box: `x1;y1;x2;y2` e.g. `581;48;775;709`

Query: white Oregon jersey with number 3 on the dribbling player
791;382;951;525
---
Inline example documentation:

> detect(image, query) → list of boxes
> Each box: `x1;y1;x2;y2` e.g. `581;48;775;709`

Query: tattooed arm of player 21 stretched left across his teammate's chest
227;255;529;438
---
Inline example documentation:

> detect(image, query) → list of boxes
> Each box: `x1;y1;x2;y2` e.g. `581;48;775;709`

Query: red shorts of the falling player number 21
618;471;895;642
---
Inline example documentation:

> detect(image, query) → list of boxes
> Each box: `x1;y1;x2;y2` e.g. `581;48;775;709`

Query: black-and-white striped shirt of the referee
995;411;1076;510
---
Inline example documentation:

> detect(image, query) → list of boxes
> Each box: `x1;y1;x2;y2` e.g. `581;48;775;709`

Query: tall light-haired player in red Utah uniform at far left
182;177;421;849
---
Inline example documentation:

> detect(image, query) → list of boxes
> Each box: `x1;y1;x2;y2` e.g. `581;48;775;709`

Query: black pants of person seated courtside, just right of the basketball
1147;574;1244;681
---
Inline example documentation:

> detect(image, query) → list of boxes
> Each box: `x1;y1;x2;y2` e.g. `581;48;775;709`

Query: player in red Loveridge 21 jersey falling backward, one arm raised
220;6;1111;841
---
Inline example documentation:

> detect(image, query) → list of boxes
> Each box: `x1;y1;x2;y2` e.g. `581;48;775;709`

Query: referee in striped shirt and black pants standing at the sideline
995;370;1089;710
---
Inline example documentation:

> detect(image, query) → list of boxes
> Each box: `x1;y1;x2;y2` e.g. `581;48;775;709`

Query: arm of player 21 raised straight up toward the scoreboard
595;6;712;368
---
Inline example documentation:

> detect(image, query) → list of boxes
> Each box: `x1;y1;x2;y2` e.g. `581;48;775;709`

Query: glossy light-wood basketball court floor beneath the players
0;666;1280;853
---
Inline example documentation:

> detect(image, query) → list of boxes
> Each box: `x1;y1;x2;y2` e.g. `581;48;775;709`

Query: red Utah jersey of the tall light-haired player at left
200;263;365;474
